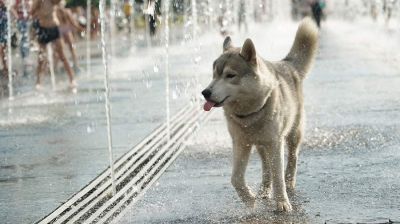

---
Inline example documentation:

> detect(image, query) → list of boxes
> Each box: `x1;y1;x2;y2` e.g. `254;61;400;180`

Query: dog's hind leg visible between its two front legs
257;145;272;198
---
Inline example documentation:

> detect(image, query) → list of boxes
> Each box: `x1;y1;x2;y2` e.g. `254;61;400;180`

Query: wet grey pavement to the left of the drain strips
0;29;204;224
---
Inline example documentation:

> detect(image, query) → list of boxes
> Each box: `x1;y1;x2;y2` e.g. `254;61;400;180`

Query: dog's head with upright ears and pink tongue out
202;37;273;114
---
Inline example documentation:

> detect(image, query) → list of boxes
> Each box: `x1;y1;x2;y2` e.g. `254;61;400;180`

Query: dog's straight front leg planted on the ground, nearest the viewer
267;139;292;212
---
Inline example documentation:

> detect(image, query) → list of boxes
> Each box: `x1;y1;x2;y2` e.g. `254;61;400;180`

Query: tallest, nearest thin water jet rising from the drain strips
99;0;116;195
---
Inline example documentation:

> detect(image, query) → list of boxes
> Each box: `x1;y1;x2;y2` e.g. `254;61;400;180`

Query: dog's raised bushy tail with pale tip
284;17;318;78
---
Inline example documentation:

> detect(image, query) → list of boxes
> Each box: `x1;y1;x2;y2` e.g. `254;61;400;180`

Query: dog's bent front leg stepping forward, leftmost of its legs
231;141;256;208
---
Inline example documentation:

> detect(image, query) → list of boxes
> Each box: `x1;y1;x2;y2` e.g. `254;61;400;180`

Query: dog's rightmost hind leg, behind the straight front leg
285;125;303;190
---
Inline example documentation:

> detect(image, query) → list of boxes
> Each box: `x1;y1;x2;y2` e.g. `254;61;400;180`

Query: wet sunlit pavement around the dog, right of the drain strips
120;20;400;223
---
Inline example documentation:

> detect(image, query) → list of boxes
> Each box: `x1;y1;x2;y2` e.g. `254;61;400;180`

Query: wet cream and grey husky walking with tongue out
202;18;318;212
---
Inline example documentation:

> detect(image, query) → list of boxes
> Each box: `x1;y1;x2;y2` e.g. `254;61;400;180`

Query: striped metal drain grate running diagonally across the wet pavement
37;105;210;224
